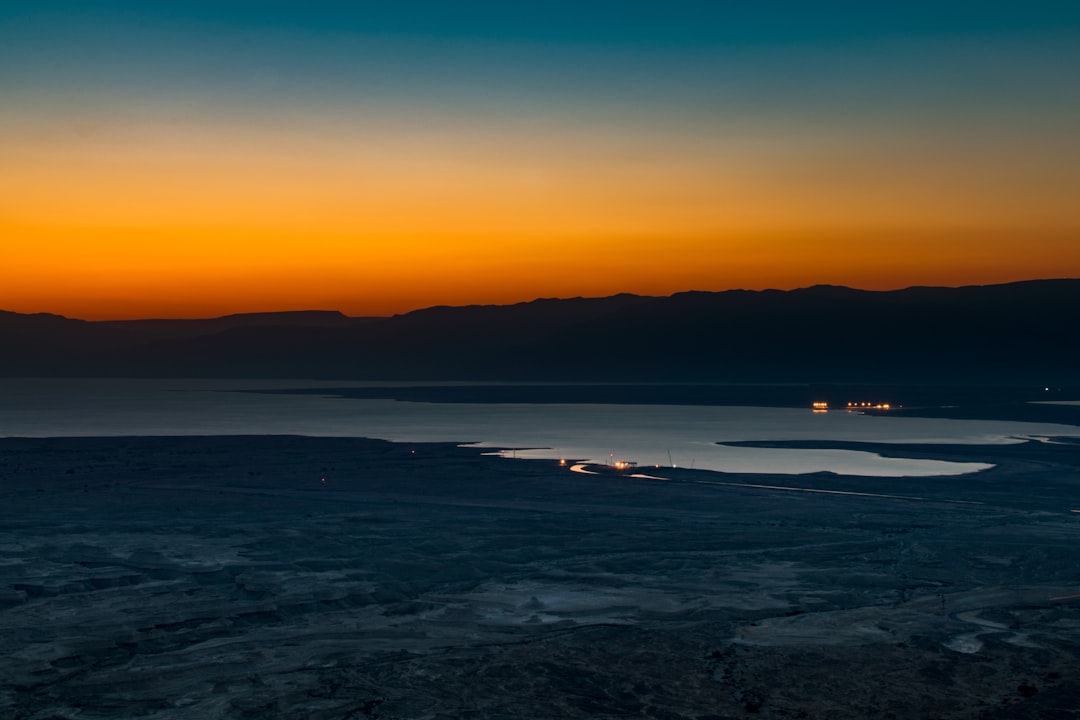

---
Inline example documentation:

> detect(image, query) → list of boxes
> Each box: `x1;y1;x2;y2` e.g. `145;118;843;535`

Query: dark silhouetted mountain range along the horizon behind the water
0;280;1080;383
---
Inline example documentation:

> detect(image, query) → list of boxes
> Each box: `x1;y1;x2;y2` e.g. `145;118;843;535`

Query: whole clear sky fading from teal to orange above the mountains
0;0;1080;320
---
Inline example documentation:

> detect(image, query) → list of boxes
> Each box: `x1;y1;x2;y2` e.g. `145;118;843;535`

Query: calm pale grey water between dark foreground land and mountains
0;379;1080;476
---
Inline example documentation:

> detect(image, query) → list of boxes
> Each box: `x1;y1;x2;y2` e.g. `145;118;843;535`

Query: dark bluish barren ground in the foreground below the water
0;437;1080;720
